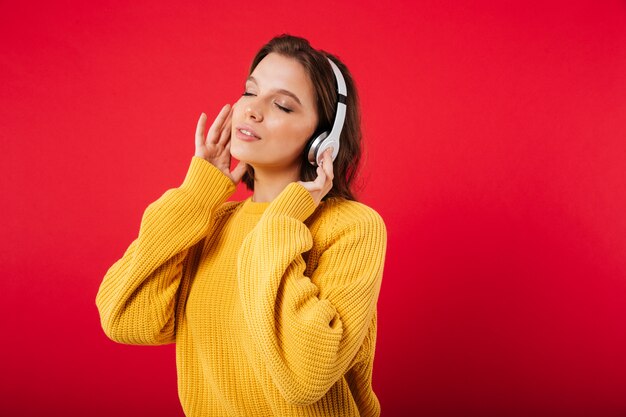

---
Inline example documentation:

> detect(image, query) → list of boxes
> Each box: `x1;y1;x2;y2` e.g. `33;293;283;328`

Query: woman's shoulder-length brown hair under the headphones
242;34;362;200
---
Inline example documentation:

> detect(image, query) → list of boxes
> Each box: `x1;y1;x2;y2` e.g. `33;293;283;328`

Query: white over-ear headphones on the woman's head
307;58;348;166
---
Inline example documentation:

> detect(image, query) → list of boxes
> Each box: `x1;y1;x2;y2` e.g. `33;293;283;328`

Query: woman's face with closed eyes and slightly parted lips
230;53;318;170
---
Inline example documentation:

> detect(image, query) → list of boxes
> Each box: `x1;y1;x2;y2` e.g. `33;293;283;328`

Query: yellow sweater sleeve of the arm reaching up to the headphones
238;183;386;405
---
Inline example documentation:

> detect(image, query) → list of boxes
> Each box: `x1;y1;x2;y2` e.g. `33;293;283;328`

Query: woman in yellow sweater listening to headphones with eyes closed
96;35;386;416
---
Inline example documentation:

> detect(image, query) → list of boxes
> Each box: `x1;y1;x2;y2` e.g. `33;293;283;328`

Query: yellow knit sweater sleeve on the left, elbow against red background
96;157;235;345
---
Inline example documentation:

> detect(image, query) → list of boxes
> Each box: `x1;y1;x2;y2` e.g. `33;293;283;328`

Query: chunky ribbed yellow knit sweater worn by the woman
96;157;386;417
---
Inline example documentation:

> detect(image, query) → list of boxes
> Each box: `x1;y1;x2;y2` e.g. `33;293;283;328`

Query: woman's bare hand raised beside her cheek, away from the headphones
195;104;246;184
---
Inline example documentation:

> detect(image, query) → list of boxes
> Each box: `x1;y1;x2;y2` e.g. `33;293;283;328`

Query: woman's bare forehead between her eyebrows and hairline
250;53;315;104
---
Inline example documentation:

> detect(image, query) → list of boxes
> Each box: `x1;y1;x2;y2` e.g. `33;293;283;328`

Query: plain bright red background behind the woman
0;0;626;416
